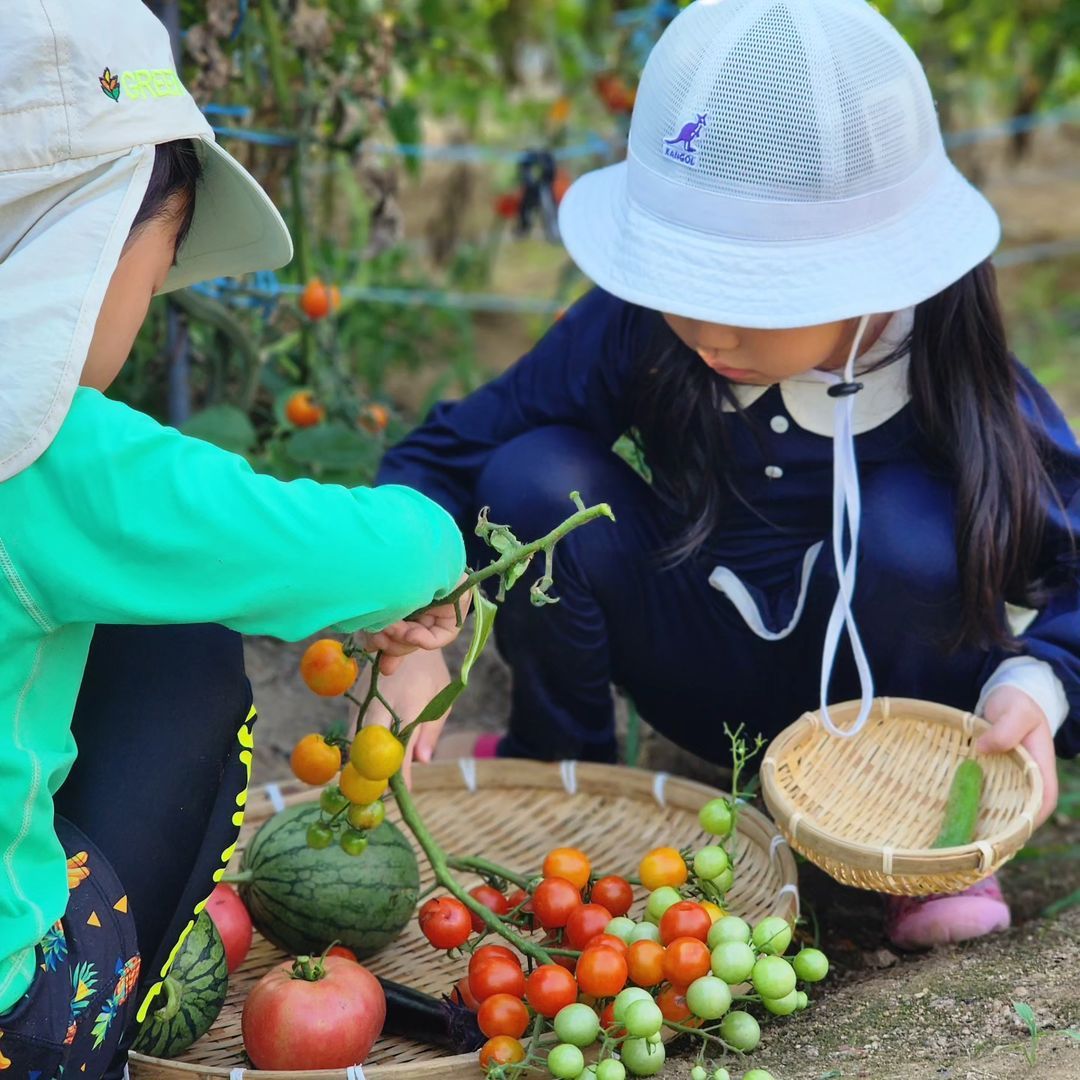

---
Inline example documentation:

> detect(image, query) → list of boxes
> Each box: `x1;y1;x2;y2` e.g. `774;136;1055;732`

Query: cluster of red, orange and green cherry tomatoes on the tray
419;799;828;1080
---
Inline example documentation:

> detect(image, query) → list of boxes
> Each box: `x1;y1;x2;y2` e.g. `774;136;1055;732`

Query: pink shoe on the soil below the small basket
885;874;1012;949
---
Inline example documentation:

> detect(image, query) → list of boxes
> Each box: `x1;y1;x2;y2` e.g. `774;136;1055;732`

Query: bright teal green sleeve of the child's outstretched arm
3;389;464;640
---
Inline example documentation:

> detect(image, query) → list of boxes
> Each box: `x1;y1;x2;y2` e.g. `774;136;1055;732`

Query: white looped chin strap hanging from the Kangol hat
810;315;874;739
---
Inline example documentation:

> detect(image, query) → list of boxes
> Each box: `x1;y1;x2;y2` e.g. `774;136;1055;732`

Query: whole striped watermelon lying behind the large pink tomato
235;804;420;959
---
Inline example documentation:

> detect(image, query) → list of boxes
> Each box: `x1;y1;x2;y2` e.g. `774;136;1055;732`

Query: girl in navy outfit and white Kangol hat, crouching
380;0;1080;946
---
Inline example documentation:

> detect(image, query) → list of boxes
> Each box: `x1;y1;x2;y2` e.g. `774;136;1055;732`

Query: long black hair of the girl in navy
629;259;1054;648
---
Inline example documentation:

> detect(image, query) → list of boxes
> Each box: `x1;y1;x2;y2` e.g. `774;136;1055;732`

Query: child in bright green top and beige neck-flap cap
0;0;464;1080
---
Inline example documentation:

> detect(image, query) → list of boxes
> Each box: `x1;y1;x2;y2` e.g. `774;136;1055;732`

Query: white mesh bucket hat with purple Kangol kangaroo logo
559;0;1000;328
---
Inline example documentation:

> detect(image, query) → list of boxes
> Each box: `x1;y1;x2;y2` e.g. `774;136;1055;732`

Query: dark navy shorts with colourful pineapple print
0;818;139;1080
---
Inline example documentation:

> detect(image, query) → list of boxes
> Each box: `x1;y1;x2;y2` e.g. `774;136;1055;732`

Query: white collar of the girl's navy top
724;308;915;437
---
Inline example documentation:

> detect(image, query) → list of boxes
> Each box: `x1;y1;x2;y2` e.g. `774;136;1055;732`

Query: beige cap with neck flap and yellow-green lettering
0;0;293;481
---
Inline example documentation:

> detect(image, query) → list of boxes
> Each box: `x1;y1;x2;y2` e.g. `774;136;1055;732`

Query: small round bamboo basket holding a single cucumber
761;698;1042;896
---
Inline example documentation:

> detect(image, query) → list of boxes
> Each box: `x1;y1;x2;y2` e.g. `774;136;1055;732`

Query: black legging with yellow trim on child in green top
55;625;254;1019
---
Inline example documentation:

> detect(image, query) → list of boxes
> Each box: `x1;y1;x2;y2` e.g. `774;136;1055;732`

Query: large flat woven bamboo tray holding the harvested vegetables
130;759;798;1080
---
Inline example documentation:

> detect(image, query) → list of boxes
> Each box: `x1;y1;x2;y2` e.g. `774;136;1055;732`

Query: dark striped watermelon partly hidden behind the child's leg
132;912;229;1057
